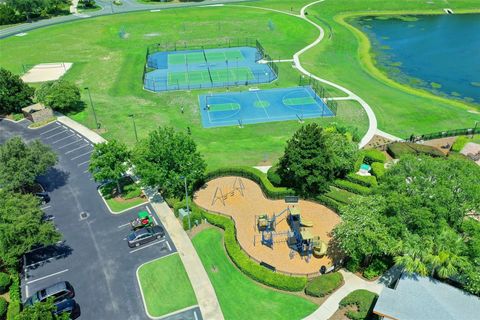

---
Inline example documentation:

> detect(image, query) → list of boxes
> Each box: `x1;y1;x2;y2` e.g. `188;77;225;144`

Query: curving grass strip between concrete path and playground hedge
192;228;318;320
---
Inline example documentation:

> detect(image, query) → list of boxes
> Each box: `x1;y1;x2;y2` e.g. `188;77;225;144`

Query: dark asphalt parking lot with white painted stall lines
0;120;201;320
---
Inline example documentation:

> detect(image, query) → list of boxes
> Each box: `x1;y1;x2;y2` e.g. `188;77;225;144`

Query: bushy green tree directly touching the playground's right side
333;196;395;264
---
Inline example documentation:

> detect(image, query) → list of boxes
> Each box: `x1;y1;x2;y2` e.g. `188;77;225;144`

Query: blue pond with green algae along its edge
356;14;480;104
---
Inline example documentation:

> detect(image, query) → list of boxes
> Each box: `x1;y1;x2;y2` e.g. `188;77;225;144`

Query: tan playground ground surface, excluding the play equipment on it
194;177;340;274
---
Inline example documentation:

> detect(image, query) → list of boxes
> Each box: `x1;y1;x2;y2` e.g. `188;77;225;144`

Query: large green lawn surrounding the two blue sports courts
0;2;367;169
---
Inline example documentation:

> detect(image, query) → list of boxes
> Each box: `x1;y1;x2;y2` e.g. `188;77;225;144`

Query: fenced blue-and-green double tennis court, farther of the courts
144;47;277;92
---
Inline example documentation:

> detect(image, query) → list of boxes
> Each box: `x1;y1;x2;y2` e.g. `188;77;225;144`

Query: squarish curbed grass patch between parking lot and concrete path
137;254;197;317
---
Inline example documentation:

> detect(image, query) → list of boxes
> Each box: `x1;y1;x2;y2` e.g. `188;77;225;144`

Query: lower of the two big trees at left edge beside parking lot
0;190;60;267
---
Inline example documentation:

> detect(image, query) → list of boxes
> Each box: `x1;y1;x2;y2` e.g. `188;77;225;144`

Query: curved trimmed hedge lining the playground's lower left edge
203;212;307;291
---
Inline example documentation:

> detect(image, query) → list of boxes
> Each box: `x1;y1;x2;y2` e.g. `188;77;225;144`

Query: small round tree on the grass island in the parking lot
88;140;130;194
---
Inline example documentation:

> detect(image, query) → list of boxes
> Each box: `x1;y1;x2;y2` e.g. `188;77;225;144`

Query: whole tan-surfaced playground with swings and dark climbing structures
194;177;340;275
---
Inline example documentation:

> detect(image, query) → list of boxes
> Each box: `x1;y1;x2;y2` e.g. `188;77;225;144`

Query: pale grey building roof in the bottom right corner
373;274;480;320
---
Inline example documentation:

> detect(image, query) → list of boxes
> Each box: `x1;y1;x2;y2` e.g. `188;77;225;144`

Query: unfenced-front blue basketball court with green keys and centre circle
198;86;334;128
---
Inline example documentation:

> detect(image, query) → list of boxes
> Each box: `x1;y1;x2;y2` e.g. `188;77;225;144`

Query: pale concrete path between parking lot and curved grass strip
151;200;224;320
